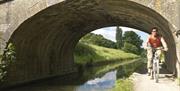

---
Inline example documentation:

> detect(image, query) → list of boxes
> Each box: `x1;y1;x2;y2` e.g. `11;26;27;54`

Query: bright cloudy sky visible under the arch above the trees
92;27;148;42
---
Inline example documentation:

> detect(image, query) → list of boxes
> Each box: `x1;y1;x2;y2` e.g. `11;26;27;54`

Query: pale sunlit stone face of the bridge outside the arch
0;0;180;86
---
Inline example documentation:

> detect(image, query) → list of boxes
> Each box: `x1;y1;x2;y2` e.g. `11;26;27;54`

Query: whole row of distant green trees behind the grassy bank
80;26;143;55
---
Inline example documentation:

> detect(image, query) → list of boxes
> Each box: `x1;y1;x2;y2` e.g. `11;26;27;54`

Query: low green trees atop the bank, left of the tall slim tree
80;33;116;48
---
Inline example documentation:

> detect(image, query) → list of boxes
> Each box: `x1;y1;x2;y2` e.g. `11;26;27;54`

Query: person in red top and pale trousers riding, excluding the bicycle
144;27;168;76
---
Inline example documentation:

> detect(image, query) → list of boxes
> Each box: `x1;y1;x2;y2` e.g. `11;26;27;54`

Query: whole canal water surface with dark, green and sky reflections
6;60;142;91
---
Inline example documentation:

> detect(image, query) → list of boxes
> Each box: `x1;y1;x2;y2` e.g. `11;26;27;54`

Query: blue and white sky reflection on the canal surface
77;71;117;91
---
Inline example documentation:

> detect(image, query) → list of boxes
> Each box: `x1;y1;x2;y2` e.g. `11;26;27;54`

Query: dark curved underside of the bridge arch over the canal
1;0;179;84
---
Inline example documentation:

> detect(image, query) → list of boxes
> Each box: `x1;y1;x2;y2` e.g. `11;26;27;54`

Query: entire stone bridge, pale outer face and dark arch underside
0;0;180;86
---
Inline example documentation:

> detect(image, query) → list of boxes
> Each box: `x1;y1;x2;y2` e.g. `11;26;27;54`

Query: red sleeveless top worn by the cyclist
148;37;162;48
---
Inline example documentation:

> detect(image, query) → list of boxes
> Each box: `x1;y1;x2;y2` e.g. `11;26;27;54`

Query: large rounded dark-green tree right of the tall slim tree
123;31;143;51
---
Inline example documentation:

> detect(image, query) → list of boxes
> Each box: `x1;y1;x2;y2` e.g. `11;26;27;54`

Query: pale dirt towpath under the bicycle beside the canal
130;68;180;91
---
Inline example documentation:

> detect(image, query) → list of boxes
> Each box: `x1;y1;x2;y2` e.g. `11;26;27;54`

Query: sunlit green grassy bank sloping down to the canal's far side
74;43;139;65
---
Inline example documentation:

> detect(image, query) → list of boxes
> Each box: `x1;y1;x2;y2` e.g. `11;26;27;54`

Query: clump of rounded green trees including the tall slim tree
116;26;143;55
